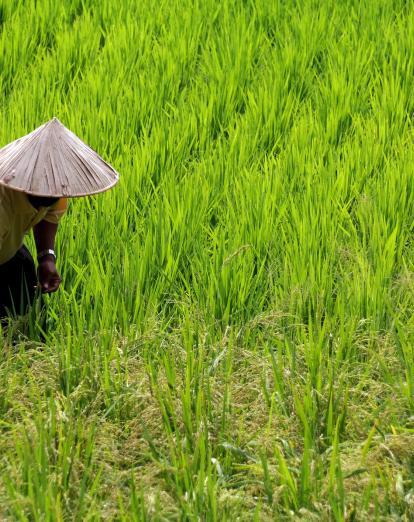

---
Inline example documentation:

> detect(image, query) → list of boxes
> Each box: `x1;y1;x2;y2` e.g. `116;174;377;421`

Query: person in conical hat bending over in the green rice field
0;118;119;319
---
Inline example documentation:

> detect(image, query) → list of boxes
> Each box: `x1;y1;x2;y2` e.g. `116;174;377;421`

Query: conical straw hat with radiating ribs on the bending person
0;118;119;197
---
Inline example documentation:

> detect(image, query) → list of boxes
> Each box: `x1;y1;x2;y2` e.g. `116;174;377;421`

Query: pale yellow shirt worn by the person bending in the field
0;185;67;265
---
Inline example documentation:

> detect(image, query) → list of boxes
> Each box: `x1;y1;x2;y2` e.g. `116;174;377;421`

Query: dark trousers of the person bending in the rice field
0;245;37;319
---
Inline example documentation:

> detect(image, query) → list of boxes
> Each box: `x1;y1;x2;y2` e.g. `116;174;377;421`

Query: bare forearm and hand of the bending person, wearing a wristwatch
33;220;62;293
